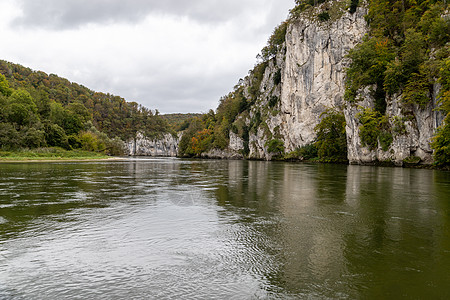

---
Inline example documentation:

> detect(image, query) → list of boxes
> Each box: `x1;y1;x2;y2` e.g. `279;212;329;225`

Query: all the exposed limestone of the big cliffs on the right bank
214;1;443;165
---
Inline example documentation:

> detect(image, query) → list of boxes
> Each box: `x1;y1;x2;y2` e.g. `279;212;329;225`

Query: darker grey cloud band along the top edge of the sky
13;0;274;29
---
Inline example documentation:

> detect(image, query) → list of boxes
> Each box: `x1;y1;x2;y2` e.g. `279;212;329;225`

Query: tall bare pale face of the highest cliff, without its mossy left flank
281;8;368;151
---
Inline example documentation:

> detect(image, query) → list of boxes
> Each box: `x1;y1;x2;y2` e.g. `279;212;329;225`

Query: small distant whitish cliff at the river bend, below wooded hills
127;132;181;157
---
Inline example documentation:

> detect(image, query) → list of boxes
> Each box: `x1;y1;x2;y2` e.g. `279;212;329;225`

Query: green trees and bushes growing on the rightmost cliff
345;0;450;165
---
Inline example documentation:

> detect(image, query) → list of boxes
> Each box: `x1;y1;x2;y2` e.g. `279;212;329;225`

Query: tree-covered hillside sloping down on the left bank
0;61;169;154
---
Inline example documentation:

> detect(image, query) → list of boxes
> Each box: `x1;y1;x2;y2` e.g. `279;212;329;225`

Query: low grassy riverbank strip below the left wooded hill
0;147;120;163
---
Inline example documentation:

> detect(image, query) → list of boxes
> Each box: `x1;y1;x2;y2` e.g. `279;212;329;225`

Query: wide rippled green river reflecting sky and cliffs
0;159;450;299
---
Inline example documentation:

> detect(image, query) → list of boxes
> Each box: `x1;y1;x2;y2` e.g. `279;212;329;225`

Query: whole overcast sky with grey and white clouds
0;0;294;113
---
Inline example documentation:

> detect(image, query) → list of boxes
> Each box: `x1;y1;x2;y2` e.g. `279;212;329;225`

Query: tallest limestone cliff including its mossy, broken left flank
223;3;367;160
